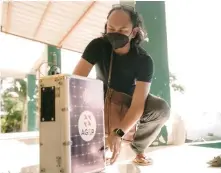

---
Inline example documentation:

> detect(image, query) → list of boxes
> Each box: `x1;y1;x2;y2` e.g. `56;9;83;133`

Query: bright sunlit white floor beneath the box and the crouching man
0;140;221;173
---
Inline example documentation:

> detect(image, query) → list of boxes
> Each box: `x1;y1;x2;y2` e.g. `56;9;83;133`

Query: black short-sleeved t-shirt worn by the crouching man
82;37;154;96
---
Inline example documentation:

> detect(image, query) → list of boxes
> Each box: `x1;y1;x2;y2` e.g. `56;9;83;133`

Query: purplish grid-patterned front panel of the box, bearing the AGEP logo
69;78;105;173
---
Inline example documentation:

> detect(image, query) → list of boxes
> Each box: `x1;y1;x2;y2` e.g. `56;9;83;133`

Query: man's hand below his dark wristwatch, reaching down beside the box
107;133;122;164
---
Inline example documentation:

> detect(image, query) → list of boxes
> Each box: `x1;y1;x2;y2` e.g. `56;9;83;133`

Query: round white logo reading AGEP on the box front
78;111;97;142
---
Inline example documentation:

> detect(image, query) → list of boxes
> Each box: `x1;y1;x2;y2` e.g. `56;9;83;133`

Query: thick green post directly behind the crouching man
135;1;170;144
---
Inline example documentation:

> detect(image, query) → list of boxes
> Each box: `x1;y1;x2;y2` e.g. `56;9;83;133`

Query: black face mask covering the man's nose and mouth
105;32;129;49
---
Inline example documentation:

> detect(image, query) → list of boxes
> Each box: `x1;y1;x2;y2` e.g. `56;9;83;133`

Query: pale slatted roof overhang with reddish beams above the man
0;0;119;52
